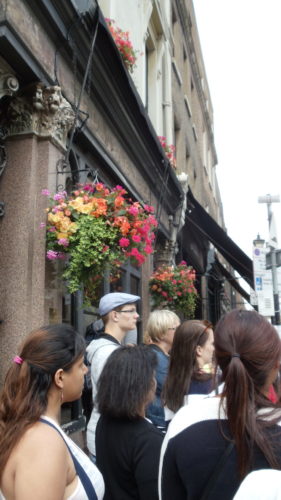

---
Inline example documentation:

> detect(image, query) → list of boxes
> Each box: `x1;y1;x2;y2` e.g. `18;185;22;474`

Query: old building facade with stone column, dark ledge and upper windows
0;0;251;402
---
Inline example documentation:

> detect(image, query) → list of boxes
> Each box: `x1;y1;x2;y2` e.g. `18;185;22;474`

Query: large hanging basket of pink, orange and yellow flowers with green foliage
42;183;157;303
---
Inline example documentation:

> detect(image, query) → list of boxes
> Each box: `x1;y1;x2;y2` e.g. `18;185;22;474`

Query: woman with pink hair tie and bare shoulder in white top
0;324;104;500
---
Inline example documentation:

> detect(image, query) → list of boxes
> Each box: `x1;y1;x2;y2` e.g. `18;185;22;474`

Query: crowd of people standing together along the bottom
0;293;281;500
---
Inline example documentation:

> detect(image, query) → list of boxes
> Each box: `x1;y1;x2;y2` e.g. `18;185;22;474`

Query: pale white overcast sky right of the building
193;0;281;257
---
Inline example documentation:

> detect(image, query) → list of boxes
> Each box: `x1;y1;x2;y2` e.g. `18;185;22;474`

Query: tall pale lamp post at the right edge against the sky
258;194;280;325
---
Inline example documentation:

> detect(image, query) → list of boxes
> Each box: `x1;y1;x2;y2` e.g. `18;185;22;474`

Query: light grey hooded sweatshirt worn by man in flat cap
86;337;120;455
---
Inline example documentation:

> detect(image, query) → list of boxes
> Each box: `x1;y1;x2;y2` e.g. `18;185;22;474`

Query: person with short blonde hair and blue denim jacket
145;309;180;431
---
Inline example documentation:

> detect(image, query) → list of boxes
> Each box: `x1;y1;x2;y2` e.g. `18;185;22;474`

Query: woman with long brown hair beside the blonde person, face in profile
162;319;214;421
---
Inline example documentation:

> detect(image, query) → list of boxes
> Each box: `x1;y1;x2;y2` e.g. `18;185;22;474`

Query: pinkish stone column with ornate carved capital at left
0;83;74;384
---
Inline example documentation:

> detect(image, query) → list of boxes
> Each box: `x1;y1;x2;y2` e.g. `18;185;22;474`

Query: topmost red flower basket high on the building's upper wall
105;18;137;73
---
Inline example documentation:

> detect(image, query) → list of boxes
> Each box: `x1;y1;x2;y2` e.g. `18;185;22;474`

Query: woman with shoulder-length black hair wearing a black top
96;345;163;500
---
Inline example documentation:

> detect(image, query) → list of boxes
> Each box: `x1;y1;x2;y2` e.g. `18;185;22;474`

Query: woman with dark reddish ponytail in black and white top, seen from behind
159;310;281;500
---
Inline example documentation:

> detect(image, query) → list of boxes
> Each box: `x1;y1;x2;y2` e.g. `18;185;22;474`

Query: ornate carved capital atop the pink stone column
1;82;75;149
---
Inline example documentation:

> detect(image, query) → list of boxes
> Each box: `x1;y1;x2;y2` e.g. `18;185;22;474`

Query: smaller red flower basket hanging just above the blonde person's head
149;260;198;319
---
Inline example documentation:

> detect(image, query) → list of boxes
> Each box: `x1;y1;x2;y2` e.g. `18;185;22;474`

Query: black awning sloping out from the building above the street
186;189;254;290
